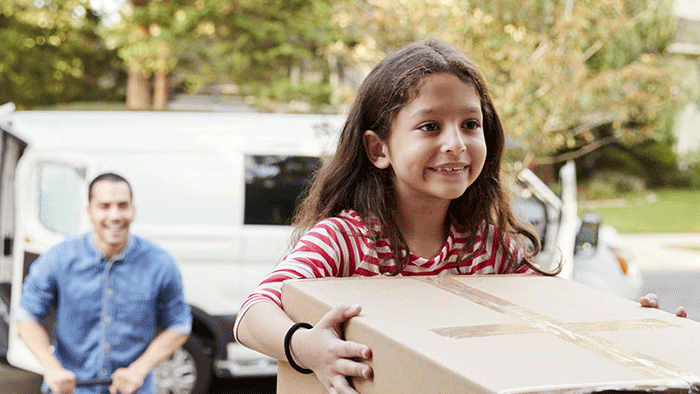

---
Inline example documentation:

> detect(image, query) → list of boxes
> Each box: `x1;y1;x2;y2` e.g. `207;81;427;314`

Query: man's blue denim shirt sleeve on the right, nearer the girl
156;255;192;335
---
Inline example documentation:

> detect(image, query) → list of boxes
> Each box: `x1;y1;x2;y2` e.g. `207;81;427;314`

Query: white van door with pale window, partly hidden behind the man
7;149;94;373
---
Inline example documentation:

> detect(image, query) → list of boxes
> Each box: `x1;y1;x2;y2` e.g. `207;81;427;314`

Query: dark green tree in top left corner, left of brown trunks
0;0;121;108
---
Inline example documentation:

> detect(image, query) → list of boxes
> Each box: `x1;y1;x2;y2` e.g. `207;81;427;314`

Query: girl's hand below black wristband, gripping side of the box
291;305;372;394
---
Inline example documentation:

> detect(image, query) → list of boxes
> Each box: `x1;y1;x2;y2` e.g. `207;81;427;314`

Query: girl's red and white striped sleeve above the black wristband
234;218;352;340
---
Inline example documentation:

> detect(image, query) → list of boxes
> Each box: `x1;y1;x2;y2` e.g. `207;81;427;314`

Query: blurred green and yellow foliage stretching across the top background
0;0;694;156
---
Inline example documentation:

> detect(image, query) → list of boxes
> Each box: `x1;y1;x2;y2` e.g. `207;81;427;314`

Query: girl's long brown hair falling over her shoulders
294;39;559;275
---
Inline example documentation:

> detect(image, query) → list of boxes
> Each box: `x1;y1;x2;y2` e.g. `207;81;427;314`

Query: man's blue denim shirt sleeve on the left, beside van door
17;245;61;321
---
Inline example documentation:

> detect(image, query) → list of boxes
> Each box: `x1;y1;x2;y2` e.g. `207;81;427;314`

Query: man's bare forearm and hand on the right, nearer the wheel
109;329;187;394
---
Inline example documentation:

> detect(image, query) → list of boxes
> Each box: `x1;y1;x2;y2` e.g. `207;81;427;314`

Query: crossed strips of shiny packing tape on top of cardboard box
413;276;700;392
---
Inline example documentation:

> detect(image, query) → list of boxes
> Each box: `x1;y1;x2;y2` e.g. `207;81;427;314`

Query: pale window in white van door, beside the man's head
39;163;83;234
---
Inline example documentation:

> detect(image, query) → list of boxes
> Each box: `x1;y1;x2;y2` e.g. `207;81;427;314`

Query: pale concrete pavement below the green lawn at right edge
622;233;700;272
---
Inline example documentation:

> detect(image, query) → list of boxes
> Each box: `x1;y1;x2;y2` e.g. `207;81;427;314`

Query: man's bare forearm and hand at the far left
17;320;75;394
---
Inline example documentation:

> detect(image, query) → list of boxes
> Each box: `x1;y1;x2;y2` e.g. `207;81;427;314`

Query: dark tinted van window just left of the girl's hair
244;155;321;225
